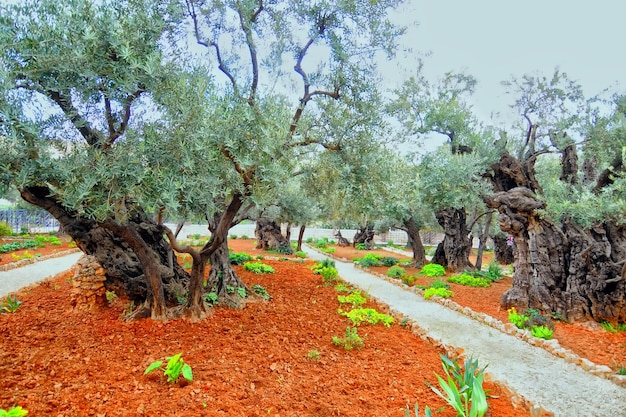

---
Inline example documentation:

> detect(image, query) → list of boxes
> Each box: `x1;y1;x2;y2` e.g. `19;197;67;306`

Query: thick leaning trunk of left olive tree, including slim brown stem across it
21;187;189;319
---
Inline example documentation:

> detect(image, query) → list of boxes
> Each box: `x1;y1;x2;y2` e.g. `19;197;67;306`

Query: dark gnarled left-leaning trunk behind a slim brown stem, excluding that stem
21;187;189;314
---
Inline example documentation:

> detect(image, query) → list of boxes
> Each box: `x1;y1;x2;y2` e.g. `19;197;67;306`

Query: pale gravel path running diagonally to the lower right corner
308;245;626;417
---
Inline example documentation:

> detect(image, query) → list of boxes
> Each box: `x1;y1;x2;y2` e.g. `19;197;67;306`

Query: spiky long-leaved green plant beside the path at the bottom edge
431;355;488;417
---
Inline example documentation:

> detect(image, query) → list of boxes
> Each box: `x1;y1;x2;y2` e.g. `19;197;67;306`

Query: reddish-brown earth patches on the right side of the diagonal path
322;246;626;370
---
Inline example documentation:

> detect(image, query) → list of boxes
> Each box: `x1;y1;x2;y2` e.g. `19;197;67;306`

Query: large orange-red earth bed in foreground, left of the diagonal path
0;240;528;417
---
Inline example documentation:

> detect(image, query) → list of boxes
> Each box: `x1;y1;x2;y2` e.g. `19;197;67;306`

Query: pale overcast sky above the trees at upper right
386;0;626;127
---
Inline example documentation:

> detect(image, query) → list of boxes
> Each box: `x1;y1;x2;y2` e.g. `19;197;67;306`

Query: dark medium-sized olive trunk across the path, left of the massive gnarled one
432;208;472;272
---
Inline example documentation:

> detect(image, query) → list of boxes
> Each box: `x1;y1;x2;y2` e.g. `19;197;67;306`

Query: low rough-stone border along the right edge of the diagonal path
309;246;626;388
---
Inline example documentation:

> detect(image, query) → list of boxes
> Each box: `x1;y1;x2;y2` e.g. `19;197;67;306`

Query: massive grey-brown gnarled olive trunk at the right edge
485;154;626;322
